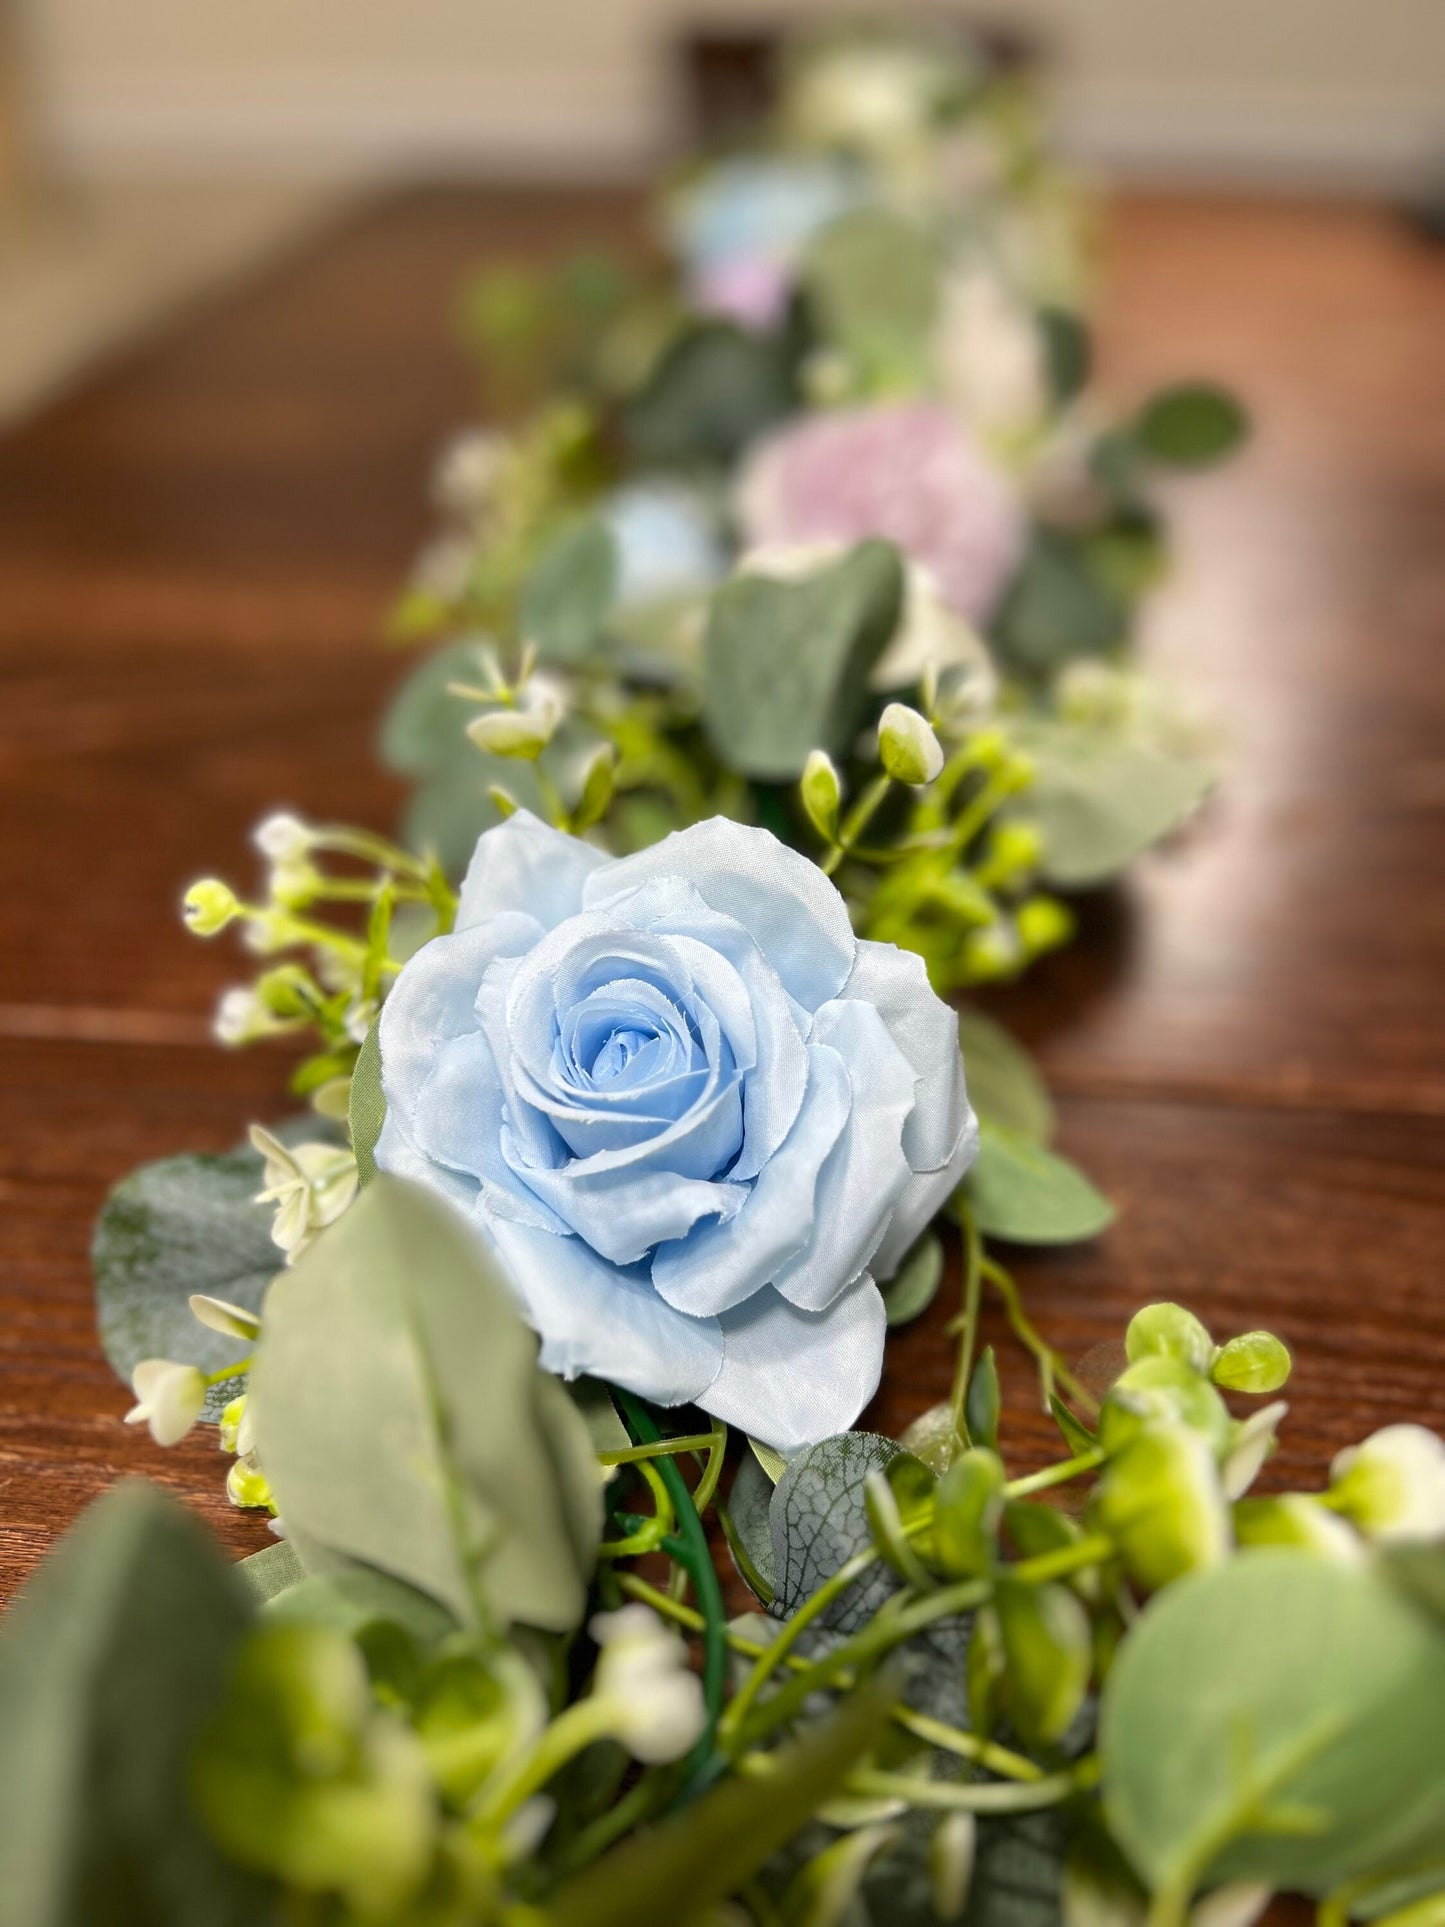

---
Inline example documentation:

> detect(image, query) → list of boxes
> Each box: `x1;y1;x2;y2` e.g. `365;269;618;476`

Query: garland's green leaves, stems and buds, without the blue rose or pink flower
0;18;1445;1927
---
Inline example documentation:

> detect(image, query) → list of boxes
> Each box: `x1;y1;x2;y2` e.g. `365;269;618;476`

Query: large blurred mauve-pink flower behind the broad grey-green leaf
738;401;1025;622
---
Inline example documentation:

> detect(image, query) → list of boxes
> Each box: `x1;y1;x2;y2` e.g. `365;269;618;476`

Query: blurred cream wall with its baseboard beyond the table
31;0;1445;187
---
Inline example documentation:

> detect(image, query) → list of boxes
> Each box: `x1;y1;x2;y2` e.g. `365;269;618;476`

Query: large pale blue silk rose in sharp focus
376;811;979;1451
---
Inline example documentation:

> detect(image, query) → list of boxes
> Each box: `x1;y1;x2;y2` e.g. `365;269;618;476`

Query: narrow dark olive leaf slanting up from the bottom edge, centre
547;1675;896;1927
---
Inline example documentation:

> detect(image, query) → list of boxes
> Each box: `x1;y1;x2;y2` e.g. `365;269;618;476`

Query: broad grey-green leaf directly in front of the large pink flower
703;541;904;782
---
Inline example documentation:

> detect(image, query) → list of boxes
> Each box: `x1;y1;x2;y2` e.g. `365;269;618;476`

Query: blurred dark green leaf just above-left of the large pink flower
624;322;798;468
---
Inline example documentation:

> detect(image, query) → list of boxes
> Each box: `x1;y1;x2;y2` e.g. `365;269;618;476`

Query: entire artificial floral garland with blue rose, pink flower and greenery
0;18;1445;1927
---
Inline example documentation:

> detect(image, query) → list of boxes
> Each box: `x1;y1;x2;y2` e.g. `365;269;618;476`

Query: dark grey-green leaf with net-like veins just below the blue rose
769;1432;902;1632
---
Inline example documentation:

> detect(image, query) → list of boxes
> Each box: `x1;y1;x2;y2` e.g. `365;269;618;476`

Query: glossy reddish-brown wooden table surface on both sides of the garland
0;189;1445;1594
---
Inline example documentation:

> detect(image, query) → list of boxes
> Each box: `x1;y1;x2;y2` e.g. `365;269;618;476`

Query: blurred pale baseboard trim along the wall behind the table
44;71;1445;195
